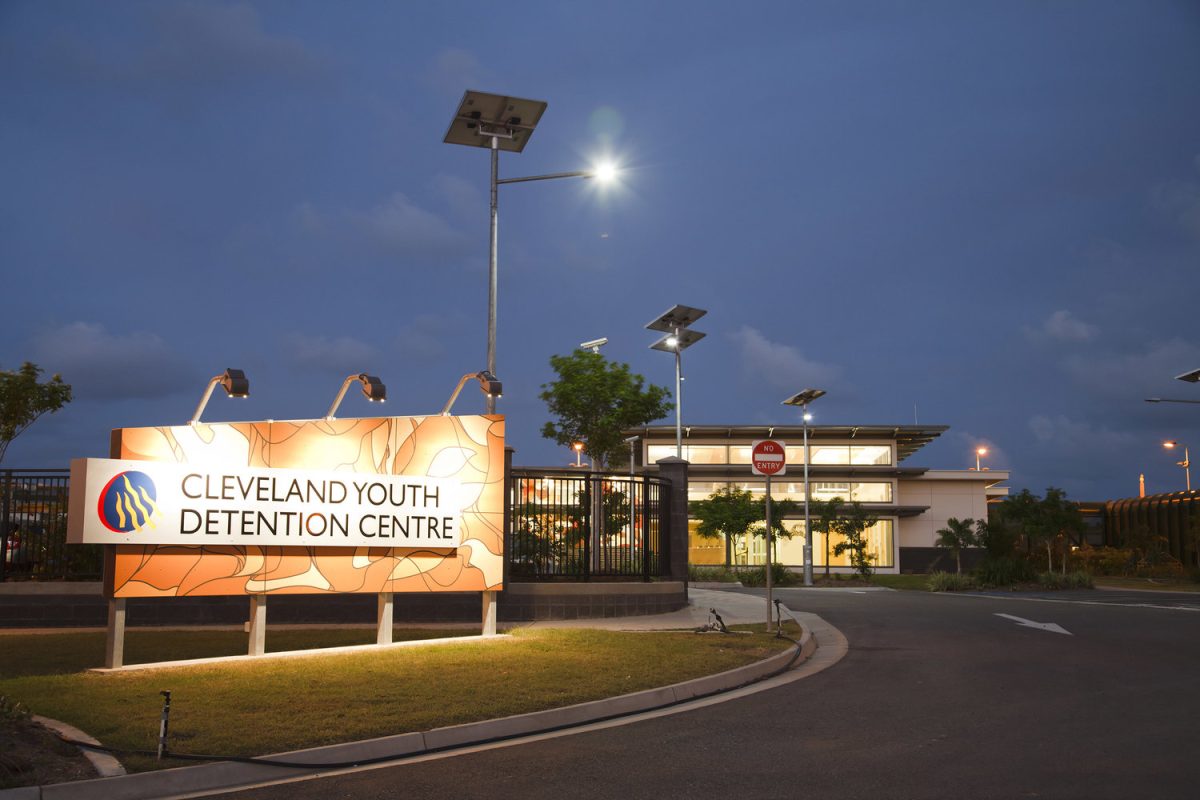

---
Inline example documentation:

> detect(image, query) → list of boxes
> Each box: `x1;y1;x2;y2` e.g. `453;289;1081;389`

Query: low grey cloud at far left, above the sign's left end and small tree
32;321;189;401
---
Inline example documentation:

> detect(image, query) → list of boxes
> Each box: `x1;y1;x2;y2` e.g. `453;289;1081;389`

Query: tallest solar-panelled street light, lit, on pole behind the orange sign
443;90;614;414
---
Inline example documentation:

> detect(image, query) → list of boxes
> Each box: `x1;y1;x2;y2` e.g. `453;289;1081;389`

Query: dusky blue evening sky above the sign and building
0;0;1200;499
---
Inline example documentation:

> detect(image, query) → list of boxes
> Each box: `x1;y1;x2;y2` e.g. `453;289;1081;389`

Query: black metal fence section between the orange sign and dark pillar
505;469;671;582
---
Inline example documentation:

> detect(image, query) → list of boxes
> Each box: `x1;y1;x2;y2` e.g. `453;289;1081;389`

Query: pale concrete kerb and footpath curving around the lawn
0;588;846;800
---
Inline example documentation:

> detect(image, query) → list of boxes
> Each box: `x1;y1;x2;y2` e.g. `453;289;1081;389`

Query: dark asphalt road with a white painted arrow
216;590;1200;800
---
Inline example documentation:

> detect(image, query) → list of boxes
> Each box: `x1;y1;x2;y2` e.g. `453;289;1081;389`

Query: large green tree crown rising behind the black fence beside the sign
541;350;674;469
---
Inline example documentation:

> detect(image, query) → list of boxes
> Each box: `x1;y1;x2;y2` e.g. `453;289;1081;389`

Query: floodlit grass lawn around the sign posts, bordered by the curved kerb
0;625;799;771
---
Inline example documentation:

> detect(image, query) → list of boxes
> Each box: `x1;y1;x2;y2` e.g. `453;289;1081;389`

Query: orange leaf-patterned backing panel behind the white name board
104;416;504;597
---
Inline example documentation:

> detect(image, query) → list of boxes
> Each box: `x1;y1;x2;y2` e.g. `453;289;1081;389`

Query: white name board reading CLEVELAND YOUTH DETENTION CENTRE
67;458;462;548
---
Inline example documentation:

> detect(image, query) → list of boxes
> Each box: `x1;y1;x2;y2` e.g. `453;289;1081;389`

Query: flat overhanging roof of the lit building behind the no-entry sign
624;425;950;461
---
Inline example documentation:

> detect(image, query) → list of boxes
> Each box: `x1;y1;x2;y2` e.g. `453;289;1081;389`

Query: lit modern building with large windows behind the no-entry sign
625;425;1008;573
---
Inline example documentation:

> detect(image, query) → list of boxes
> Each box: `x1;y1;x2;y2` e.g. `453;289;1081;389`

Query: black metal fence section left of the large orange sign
0;469;103;581
